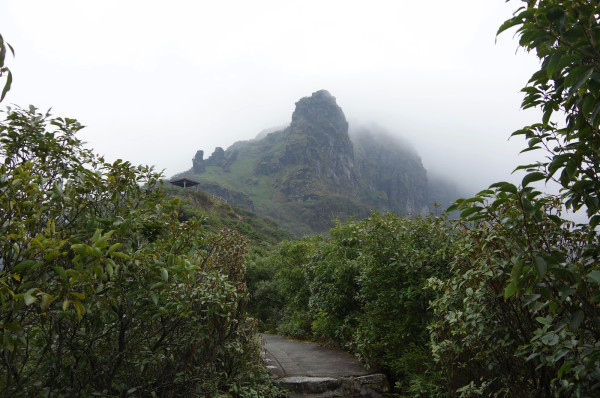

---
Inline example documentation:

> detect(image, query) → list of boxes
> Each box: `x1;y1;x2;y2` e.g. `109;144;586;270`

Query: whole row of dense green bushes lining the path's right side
248;213;454;393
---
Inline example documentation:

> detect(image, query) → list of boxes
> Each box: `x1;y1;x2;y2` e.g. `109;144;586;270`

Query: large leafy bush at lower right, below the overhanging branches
430;190;598;397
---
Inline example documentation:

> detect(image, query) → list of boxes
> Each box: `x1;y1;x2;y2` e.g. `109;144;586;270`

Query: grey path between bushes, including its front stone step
261;334;387;397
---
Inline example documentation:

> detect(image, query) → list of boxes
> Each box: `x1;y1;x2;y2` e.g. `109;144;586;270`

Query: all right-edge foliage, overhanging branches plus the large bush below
431;0;600;397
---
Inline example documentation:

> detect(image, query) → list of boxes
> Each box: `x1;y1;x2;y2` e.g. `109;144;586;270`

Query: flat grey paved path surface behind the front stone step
261;334;370;377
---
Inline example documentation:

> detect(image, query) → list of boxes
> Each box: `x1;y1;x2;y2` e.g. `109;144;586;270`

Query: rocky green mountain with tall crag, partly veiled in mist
178;90;458;235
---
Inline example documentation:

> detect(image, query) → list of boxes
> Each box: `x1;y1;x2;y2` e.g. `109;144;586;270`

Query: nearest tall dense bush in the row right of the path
346;214;455;396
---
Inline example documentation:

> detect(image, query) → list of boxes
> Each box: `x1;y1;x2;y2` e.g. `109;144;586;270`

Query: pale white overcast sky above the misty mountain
0;0;538;193
